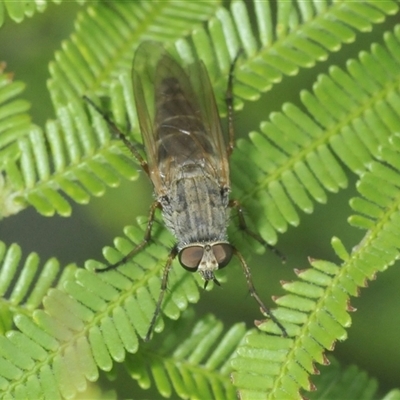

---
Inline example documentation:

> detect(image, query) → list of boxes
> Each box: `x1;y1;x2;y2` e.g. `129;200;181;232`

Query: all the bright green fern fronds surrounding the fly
0;1;400;399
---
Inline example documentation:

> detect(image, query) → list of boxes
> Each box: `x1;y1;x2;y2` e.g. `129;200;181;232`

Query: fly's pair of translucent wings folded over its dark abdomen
133;42;229;194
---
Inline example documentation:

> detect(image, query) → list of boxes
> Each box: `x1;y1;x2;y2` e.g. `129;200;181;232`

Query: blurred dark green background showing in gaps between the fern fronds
0;2;400;393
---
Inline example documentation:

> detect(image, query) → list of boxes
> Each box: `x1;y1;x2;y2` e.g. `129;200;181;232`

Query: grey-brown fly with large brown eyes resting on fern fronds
86;41;286;341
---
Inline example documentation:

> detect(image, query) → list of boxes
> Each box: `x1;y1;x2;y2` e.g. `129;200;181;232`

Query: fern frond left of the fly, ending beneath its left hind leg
3;99;138;216
